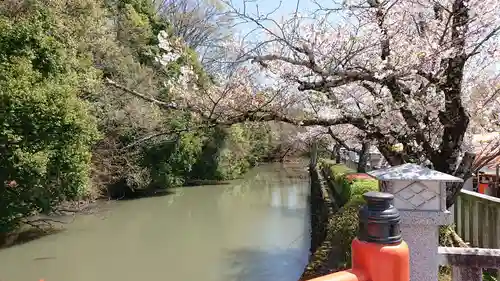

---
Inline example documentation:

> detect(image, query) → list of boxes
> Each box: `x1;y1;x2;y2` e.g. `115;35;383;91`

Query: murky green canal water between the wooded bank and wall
0;164;310;281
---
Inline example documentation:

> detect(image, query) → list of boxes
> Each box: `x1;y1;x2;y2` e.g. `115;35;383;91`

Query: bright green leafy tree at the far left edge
0;11;98;232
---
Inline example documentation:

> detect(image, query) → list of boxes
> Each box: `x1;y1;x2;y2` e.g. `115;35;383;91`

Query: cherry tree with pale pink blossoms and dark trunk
216;0;500;204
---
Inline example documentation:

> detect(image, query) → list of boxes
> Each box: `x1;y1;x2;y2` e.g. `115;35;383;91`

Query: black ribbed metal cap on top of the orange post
358;191;402;244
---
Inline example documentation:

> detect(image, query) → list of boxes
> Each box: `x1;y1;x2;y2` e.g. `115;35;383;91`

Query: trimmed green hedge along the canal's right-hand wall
319;160;379;270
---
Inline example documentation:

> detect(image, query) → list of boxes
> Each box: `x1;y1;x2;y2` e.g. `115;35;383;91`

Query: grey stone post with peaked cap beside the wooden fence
368;164;462;281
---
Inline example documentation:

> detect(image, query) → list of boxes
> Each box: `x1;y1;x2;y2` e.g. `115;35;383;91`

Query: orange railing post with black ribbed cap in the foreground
311;192;410;281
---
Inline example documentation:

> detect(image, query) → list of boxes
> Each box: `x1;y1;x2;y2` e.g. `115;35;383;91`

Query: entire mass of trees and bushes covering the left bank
0;0;278;232
